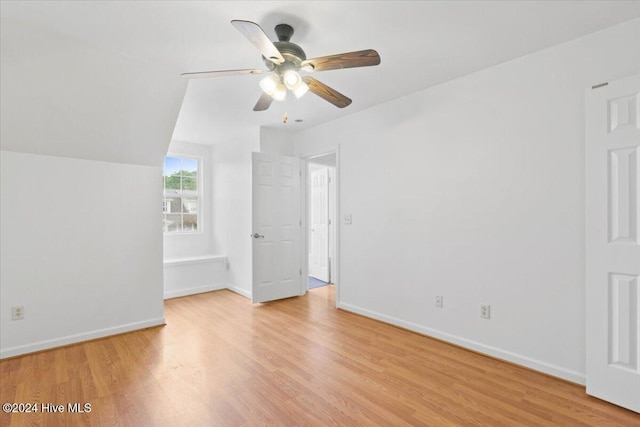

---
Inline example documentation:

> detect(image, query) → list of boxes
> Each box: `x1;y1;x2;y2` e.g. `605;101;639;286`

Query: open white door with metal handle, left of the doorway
251;153;304;303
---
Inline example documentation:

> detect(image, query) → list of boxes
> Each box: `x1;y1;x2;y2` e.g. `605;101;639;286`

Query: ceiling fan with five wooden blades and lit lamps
182;20;380;111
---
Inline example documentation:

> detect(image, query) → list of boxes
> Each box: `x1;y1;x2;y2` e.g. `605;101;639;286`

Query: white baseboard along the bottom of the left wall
0;317;165;359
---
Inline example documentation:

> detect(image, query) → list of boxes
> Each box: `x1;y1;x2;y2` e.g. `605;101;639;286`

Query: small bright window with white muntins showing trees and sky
162;156;200;233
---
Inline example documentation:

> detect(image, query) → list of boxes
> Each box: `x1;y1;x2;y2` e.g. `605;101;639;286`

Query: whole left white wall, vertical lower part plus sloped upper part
0;11;186;357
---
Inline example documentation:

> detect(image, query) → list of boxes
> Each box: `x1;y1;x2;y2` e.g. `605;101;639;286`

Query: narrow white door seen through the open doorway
309;167;329;282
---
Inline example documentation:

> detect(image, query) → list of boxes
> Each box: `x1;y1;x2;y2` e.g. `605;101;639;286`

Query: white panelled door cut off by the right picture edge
585;75;640;412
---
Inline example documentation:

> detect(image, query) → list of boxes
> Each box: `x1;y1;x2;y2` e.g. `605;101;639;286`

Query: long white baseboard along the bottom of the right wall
338;303;586;385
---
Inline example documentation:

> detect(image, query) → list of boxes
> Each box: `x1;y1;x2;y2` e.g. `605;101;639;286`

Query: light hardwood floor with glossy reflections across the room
0;286;640;427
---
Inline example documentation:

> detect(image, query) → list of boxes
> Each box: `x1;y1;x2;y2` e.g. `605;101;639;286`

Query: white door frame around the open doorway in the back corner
300;146;341;308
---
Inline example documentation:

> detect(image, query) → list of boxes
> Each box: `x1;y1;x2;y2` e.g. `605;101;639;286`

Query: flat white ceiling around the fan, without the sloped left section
1;1;640;151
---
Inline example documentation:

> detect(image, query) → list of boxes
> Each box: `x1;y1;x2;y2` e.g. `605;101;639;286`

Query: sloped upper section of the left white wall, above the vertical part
0;15;187;166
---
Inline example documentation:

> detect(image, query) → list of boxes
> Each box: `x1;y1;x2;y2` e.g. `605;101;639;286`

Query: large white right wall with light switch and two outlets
296;20;640;383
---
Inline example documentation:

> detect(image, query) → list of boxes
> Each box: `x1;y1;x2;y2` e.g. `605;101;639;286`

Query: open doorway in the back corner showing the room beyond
306;153;337;289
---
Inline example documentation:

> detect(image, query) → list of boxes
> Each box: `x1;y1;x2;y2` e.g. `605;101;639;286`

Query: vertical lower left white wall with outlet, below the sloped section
0;151;164;357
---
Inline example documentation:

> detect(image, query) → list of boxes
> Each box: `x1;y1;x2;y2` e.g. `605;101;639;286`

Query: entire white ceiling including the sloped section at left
0;1;640;164
